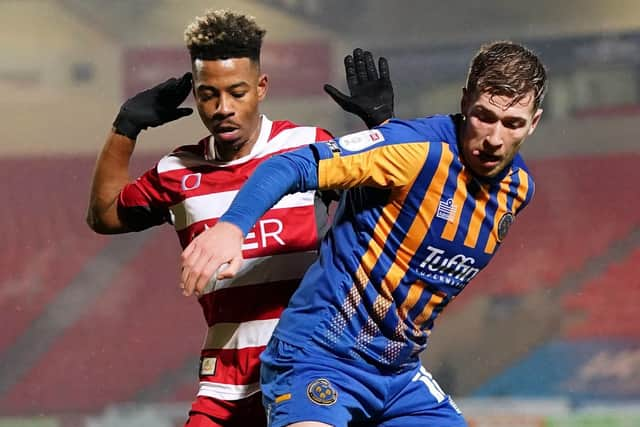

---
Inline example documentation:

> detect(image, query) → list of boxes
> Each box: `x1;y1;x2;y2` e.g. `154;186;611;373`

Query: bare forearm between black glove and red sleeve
87;131;135;234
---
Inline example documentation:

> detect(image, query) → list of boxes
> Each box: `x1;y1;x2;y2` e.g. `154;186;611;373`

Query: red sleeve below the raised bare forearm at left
118;168;171;231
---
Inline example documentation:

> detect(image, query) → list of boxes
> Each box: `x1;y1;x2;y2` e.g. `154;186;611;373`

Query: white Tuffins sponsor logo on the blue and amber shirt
419;246;480;288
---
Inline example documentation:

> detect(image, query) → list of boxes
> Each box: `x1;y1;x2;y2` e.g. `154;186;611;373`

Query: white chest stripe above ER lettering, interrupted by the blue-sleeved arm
169;190;314;231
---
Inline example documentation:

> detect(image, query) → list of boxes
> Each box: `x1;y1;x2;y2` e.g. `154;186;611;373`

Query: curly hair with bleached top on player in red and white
184;9;266;63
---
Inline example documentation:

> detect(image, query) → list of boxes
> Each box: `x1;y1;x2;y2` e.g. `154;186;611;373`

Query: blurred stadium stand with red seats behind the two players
0;0;640;427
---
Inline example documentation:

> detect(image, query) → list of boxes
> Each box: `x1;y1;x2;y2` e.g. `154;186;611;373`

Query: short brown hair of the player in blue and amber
466;41;547;109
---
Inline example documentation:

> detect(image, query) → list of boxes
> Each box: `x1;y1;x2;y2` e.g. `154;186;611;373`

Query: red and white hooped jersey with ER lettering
118;116;331;400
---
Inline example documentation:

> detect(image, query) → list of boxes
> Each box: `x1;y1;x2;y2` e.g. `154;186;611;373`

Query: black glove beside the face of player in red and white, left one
113;73;193;139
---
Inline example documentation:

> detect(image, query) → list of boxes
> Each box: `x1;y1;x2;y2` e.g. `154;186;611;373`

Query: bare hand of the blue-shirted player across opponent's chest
180;222;244;297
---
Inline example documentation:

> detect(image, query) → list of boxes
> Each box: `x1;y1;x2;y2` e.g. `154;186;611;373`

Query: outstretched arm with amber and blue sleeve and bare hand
180;130;427;296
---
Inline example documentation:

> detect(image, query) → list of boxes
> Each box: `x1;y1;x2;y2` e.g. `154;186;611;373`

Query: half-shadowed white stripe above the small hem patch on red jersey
203;319;278;350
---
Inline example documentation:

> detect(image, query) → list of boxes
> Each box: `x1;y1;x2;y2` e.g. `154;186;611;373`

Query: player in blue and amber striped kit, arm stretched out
181;42;546;427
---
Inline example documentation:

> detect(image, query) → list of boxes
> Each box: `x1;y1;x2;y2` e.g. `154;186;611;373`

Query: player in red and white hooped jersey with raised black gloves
87;10;393;427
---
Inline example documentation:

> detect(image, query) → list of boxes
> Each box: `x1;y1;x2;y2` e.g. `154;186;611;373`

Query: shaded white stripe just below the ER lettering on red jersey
203;251;318;294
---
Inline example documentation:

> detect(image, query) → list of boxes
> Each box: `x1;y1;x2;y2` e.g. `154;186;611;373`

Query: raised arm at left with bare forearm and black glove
87;73;193;234
